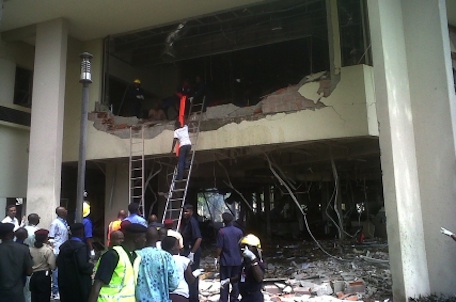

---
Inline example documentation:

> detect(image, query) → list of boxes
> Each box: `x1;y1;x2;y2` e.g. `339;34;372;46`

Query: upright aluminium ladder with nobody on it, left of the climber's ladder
128;125;144;210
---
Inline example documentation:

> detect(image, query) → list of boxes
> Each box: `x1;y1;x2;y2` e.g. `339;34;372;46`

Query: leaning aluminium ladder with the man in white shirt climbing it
162;97;206;230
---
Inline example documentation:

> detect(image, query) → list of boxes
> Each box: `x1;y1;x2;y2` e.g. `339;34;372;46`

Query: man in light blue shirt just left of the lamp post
49;207;69;300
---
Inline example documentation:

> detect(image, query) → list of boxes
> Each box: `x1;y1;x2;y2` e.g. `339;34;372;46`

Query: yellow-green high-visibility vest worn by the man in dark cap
97;246;141;302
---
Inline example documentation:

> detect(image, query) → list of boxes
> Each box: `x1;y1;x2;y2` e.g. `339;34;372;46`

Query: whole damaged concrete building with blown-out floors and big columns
0;0;456;301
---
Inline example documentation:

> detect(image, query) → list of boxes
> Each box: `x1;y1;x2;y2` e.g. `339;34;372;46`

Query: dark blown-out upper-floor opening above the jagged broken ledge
104;0;371;115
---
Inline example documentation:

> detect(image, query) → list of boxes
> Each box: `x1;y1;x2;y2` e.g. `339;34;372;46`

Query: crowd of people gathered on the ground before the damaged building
0;203;265;302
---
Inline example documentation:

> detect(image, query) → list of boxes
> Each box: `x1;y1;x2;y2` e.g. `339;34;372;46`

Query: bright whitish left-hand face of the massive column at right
368;0;434;301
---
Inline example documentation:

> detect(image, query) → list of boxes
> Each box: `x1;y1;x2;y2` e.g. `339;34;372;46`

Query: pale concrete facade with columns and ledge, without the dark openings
0;0;456;301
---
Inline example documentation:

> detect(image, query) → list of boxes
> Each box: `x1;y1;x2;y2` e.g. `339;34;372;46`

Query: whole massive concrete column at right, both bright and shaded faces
368;0;456;301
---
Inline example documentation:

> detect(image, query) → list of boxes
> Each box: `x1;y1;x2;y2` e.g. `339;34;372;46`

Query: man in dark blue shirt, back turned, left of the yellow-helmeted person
216;212;243;302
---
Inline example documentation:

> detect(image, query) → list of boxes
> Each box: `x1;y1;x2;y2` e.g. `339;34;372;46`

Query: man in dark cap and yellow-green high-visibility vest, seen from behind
89;223;147;302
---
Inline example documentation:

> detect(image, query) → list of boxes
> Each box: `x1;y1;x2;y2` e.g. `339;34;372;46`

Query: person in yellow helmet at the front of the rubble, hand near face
220;234;265;302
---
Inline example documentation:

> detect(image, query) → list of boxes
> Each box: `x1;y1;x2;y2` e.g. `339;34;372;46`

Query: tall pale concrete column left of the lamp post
27;19;68;228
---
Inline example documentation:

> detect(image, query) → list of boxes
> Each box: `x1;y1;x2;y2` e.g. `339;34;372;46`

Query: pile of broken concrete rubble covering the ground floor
200;241;392;302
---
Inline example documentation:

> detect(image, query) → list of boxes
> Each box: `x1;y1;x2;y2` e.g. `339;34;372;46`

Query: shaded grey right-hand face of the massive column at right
402;0;456;296
